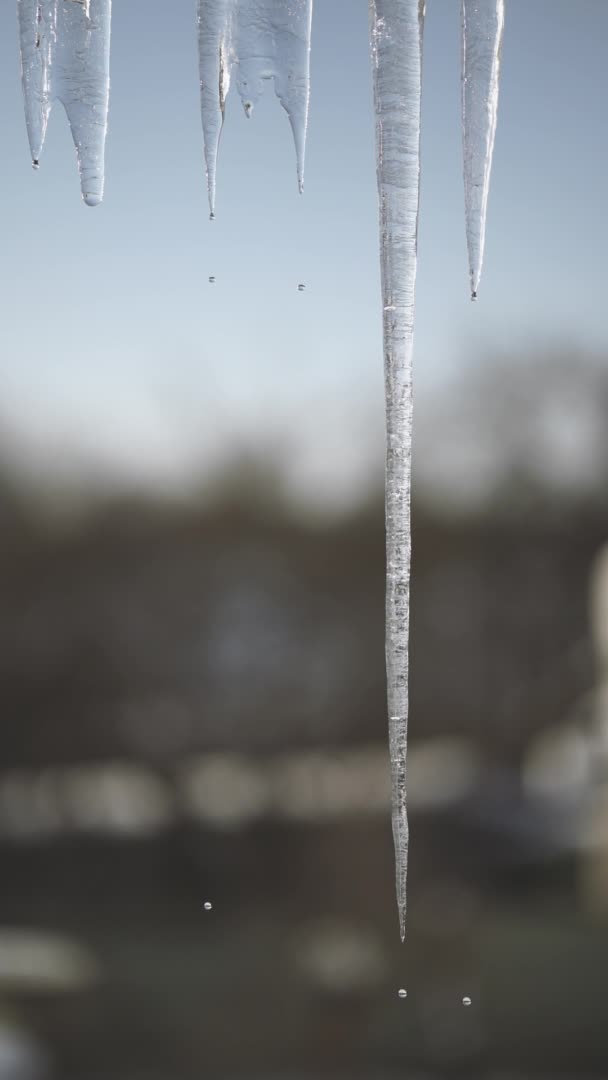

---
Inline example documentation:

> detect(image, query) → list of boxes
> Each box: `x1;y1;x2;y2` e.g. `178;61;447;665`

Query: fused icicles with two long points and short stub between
199;0;312;217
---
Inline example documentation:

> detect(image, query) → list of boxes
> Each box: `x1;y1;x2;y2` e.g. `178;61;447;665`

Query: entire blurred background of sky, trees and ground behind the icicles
0;0;608;1080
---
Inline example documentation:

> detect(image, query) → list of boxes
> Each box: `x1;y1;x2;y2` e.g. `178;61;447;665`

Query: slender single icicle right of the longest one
462;0;504;300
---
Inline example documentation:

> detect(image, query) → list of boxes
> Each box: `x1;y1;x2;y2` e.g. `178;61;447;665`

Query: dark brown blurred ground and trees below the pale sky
0;349;608;1080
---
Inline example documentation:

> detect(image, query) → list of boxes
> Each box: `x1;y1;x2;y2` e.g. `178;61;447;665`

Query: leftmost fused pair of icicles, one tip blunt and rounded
17;0;111;206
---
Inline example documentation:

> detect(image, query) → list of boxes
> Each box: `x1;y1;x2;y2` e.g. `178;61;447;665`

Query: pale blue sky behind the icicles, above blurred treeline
0;0;608;498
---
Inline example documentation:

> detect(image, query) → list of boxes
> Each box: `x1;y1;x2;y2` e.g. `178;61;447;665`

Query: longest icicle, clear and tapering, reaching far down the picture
369;0;424;941
